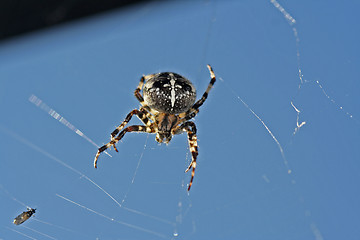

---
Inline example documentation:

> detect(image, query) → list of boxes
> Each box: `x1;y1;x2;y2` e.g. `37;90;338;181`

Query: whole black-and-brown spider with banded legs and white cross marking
94;65;216;191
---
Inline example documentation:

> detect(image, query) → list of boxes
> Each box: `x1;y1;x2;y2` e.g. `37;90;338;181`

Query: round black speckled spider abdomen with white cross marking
143;72;196;114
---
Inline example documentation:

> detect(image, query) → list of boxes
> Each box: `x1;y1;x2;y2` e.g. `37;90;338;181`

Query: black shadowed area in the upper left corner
0;0;146;40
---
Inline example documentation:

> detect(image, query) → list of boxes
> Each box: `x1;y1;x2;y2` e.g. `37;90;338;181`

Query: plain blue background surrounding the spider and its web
0;0;360;240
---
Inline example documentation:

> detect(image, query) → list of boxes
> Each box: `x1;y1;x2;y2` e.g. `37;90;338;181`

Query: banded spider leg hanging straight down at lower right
174;121;199;191
